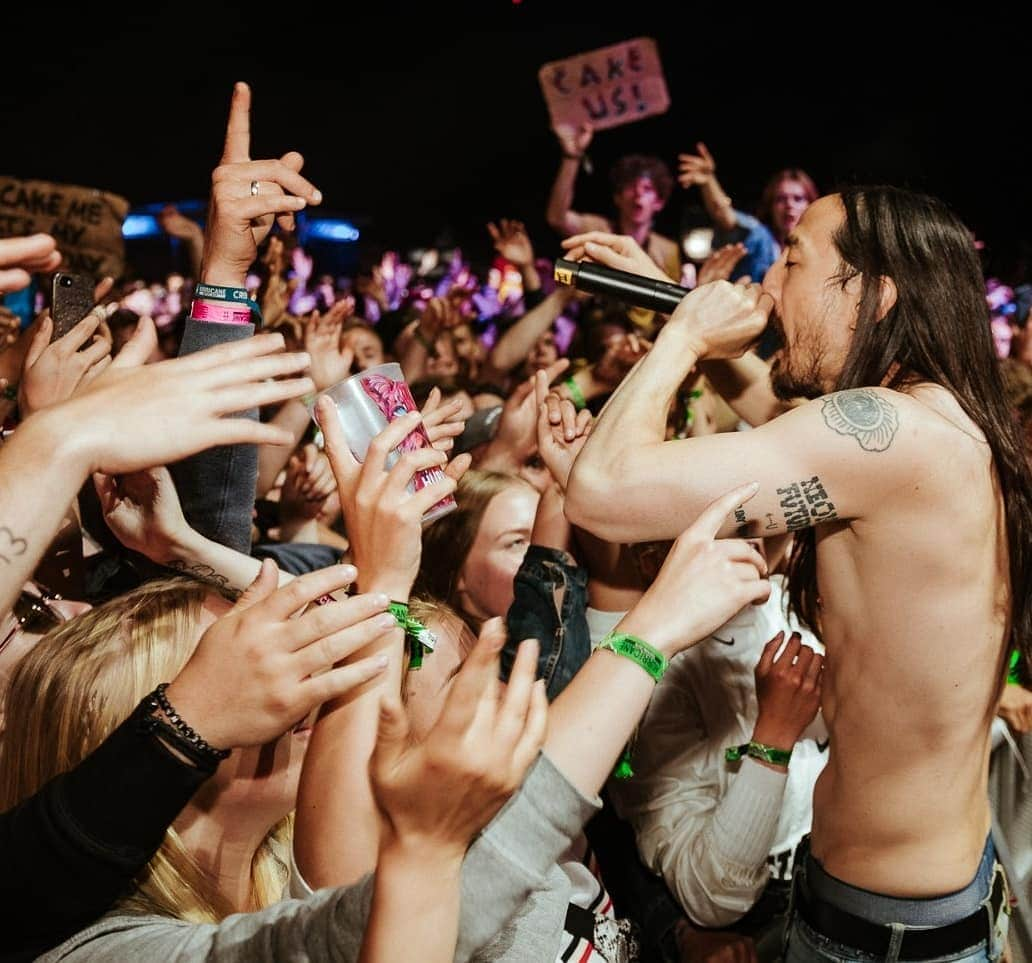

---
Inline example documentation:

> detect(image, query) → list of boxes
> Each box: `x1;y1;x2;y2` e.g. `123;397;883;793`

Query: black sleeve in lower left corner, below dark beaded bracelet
0;703;214;960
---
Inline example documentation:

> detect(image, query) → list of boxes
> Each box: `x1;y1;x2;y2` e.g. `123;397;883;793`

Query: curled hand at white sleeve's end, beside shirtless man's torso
752;632;825;751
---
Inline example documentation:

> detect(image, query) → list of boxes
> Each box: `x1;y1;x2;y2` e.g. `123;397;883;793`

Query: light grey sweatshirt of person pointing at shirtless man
39;753;601;963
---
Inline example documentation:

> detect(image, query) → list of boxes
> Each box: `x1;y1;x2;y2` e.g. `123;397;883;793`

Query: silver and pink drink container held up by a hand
313;362;456;522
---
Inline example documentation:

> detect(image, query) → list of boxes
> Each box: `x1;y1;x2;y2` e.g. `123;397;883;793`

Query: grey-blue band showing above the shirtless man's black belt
806;837;996;926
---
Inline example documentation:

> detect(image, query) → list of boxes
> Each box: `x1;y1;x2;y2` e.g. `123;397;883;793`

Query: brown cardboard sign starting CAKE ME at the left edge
0;176;129;278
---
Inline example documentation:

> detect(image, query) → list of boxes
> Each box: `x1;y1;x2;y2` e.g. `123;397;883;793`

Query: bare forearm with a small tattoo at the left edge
0;406;91;612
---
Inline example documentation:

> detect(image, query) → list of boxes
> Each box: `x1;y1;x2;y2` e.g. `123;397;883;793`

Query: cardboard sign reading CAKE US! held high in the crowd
538;37;670;130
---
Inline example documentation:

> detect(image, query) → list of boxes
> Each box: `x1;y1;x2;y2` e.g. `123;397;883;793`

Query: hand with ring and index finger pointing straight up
201;84;322;287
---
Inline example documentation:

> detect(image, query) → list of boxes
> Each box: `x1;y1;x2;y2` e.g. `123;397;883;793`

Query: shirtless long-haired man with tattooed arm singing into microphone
567;188;1032;961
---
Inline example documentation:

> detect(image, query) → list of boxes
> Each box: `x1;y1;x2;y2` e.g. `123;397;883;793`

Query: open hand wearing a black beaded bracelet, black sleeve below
168;559;396;747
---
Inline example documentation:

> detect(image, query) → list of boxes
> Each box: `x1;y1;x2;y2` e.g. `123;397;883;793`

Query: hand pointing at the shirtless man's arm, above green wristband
621;482;771;656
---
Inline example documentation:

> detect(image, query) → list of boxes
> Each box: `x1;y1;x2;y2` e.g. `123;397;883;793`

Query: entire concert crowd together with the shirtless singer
0;78;1032;963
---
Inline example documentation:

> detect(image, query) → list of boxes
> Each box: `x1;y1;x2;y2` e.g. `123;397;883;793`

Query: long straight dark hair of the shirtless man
788;187;1032;668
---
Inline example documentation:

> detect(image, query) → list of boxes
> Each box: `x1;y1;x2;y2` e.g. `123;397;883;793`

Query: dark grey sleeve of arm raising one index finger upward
168;319;258;555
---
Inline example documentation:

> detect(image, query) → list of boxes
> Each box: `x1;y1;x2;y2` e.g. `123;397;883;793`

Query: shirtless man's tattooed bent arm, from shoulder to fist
567;282;924;542
